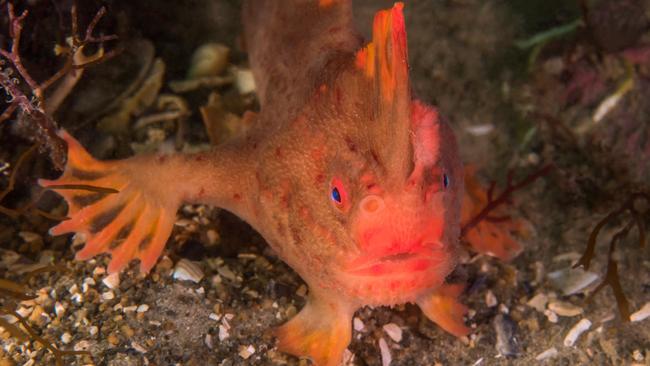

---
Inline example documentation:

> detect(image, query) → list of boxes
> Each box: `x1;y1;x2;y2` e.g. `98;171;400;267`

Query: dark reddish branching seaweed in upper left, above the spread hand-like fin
0;2;118;170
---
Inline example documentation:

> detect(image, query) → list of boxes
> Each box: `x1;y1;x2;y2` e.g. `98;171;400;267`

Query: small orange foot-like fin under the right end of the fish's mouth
417;284;470;337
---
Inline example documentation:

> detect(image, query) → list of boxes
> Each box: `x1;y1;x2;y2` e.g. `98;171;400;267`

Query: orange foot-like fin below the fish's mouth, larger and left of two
276;295;353;366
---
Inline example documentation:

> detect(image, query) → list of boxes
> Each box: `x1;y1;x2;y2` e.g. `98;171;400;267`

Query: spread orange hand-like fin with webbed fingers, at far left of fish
39;132;180;273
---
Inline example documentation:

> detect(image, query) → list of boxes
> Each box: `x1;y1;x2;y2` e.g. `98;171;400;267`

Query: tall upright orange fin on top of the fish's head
355;2;412;183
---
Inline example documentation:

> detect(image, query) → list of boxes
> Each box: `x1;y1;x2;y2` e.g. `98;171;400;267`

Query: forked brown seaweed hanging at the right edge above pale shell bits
573;192;650;322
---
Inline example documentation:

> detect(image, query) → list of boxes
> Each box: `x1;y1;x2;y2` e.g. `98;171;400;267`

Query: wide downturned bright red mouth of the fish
346;248;444;277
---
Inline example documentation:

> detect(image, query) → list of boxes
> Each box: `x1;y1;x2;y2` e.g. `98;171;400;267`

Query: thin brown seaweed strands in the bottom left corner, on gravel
0;265;91;366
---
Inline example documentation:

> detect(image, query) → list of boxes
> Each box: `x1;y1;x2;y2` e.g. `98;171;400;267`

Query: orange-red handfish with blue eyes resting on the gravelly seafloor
39;0;469;366
